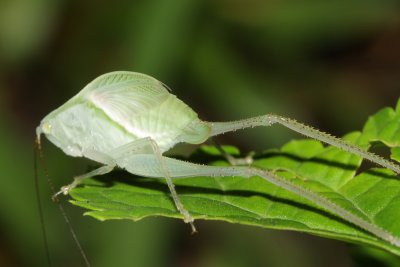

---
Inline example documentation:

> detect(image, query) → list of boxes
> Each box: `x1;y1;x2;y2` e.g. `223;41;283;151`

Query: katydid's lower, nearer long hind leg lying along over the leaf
126;155;400;247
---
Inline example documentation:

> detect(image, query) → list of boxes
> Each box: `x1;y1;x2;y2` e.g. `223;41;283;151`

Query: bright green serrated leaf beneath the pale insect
71;102;400;255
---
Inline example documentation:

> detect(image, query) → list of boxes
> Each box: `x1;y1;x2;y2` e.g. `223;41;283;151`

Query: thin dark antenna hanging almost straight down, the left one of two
33;142;52;267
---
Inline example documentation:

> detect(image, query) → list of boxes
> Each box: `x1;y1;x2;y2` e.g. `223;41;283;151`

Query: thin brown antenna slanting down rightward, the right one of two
36;138;90;267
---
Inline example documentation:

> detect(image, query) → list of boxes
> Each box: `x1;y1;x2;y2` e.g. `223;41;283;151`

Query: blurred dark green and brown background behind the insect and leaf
0;0;400;267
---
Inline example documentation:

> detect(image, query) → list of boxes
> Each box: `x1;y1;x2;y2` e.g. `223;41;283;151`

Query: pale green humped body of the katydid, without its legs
37;72;210;163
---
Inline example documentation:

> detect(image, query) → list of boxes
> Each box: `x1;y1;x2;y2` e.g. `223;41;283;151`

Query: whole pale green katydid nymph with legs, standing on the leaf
36;71;400;246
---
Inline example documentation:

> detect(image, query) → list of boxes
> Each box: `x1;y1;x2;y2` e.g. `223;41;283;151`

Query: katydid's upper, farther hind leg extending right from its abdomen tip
209;114;400;174
